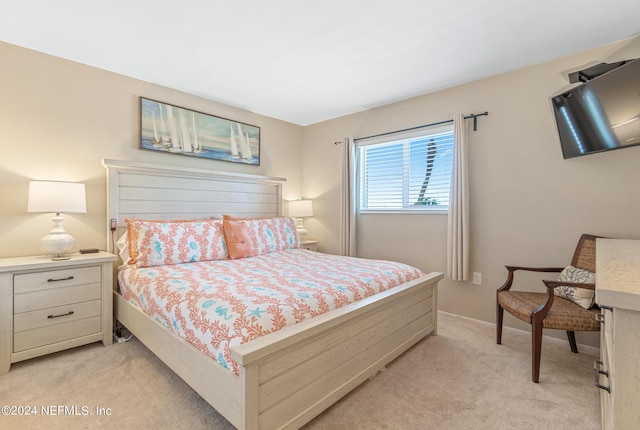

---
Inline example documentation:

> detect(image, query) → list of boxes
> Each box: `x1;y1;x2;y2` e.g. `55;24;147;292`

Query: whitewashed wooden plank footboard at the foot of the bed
232;273;442;429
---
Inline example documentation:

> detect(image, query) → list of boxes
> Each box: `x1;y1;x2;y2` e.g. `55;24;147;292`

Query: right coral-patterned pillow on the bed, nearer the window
222;215;302;259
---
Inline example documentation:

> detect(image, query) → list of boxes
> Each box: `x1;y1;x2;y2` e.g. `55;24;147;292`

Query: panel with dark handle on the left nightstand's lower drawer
13;299;102;333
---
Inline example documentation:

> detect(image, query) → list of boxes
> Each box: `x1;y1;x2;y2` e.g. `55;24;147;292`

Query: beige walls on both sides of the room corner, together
0;39;640;345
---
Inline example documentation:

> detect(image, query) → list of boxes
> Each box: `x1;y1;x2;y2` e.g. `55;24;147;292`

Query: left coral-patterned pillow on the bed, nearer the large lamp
126;219;229;267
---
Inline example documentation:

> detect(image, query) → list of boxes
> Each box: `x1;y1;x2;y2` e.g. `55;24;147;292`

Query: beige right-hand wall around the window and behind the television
303;39;640;345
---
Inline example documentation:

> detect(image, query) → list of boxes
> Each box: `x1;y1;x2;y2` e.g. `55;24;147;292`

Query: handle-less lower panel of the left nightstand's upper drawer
13;282;102;315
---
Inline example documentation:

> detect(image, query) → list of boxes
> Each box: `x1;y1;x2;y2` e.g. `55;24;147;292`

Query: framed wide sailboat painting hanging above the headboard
140;97;260;166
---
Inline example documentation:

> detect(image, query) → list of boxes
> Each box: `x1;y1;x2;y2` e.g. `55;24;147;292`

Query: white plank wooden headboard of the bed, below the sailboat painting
102;159;286;252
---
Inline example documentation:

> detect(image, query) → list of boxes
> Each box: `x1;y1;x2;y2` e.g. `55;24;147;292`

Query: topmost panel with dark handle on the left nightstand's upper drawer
13;266;102;294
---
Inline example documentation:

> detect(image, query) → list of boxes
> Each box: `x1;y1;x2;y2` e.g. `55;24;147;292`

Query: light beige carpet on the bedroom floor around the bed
0;313;600;430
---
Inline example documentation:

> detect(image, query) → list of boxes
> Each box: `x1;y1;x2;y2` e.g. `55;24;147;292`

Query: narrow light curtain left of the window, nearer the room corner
340;137;357;256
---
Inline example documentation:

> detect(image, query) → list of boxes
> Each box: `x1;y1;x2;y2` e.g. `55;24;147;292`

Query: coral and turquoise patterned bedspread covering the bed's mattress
118;249;424;374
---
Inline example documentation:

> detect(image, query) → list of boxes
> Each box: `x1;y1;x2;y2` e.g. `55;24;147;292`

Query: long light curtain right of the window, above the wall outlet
446;113;469;281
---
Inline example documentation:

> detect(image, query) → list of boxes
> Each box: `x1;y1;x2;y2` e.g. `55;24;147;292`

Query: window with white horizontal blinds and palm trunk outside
358;127;453;213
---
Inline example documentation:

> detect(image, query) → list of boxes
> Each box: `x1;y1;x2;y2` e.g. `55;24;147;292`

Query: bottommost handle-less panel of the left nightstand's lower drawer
13;315;102;353
